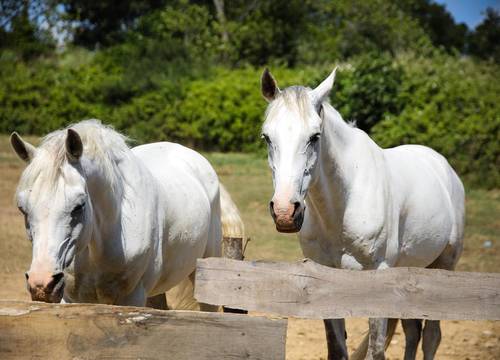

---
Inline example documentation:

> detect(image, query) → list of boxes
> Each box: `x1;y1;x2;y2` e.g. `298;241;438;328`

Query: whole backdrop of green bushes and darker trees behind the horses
0;0;500;186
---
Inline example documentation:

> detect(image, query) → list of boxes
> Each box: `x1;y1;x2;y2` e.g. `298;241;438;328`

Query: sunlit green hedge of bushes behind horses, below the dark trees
0;45;500;187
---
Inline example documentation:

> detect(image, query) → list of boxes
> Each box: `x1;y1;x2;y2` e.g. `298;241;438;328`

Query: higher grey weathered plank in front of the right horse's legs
195;258;500;320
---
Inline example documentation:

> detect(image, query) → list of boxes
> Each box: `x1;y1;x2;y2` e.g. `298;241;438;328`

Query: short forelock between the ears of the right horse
265;86;313;126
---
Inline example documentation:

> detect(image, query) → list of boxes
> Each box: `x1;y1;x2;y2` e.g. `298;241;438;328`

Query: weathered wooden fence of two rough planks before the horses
0;258;500;360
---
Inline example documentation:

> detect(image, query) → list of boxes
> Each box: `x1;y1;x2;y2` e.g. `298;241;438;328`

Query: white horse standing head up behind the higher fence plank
261;69;465;359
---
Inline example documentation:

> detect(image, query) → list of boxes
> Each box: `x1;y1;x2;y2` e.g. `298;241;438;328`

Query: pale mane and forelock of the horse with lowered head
17;119;130;197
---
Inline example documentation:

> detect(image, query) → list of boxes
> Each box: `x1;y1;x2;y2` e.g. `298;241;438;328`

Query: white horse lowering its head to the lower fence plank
11;120;241;310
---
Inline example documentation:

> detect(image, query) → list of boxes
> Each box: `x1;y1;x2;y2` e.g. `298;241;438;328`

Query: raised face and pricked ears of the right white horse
262;69;335;232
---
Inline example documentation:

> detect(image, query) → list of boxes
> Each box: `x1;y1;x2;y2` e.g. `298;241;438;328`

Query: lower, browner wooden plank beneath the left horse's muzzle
0;301;286;360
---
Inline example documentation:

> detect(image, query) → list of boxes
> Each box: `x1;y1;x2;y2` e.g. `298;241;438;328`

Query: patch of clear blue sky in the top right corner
435;0;500;29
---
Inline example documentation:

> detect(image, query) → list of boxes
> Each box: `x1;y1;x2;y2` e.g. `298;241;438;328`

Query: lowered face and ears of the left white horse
11;130;92;302
